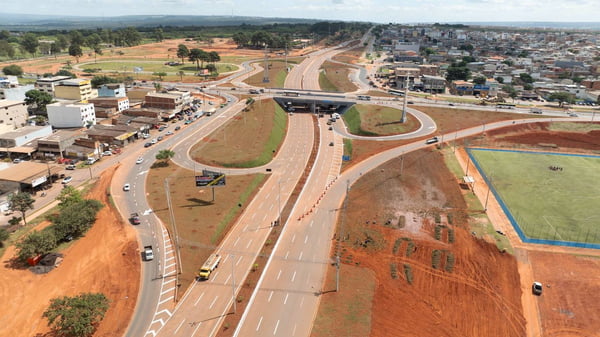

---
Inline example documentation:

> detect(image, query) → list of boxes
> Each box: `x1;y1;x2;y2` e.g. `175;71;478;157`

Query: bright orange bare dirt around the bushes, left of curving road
0;167;140;337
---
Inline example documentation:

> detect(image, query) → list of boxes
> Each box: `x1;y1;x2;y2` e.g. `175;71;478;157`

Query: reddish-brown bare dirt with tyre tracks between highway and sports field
313;150;525;337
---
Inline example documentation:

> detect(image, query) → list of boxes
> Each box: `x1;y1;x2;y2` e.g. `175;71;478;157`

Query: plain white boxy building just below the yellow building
46;102;96;128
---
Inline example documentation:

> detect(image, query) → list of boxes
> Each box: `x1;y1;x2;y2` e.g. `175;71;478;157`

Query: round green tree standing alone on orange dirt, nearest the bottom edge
43;293;110;337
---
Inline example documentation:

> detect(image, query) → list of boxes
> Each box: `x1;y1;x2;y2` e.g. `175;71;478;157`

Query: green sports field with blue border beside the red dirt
470;149;600;244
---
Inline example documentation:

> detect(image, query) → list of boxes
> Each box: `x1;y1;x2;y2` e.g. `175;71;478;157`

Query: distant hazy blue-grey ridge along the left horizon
0;13;323;31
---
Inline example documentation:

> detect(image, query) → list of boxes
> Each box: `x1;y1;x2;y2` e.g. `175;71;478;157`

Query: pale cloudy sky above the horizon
0;0;600;23
